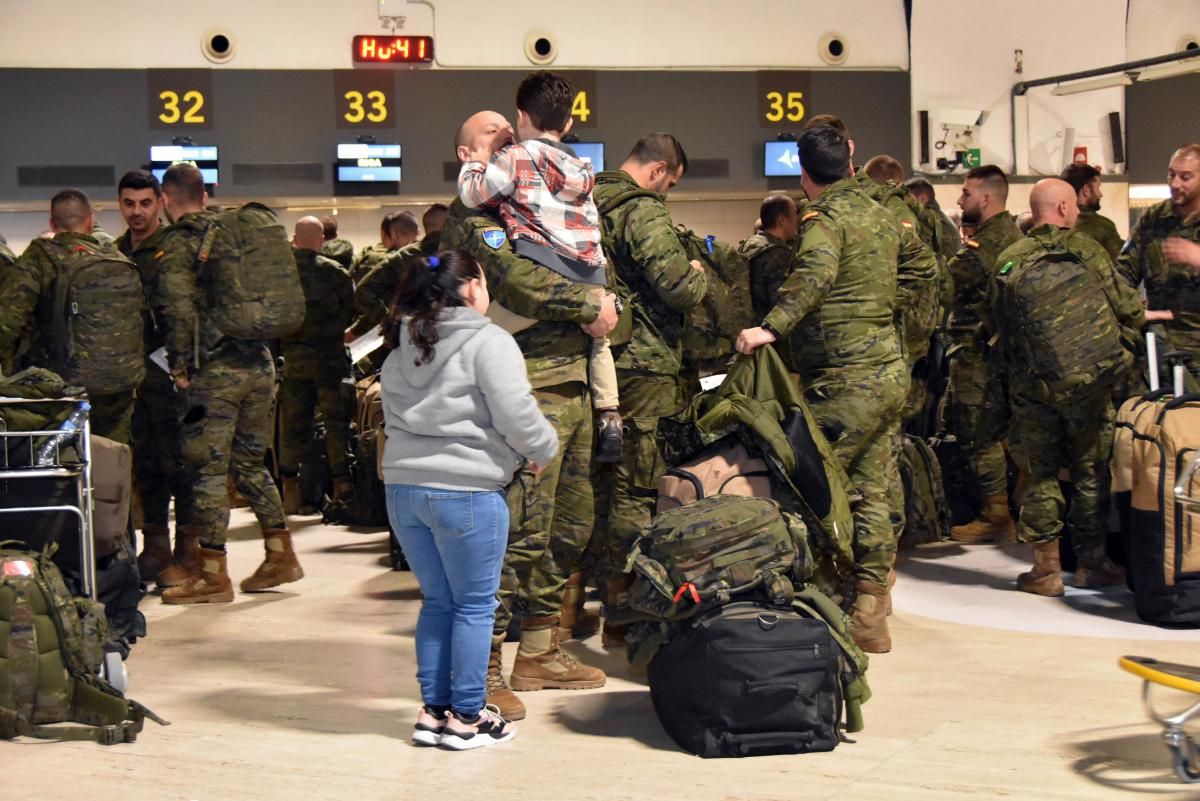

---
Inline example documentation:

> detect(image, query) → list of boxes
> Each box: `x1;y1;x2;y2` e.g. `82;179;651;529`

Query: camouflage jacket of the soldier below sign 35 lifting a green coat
764;179;902;374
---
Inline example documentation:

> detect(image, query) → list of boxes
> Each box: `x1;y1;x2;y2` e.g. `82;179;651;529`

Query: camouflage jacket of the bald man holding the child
438;199;600;389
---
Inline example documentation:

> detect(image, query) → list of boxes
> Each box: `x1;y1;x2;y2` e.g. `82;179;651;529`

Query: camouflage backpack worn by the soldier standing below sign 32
196;203;305;342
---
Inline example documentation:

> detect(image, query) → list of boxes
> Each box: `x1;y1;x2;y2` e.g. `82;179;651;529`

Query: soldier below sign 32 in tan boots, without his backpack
155;163;304;604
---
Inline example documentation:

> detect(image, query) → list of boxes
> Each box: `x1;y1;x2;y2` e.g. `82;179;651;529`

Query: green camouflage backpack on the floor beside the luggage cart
0;541;169;746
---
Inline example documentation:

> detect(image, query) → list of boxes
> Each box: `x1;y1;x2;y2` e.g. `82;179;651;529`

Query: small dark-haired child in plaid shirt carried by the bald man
458;72;623;462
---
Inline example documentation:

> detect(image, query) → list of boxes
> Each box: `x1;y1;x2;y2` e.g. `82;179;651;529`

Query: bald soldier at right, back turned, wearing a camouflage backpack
982;179;1146;596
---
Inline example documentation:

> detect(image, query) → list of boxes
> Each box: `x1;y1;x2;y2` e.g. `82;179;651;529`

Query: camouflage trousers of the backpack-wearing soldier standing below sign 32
180;345;287;546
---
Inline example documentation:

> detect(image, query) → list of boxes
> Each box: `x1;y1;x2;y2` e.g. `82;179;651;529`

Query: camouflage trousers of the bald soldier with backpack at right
1008;391;1116;565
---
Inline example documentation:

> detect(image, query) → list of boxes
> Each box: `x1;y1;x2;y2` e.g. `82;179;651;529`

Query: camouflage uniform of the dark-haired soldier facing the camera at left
116;225;192;528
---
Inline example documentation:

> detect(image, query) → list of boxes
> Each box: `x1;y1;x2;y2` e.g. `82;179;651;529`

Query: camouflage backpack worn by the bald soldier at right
996;243;1130;403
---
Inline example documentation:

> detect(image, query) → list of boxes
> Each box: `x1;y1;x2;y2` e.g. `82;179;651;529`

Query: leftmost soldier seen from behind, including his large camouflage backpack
0;189;145;445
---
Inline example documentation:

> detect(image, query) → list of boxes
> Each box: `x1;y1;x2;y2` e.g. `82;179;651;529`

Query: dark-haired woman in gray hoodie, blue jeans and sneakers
382;251;558;751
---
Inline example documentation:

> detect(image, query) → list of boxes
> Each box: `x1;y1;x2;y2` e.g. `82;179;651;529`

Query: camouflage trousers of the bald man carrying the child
494;383;593;633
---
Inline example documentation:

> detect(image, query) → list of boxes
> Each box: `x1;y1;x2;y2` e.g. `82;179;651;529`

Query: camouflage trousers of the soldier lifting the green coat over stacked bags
802;360;910;586
